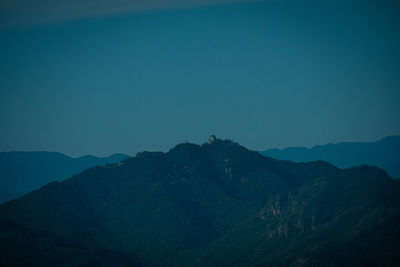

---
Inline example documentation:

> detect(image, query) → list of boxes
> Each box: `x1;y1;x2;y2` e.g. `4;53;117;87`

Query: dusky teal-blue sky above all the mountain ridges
0;0;400;156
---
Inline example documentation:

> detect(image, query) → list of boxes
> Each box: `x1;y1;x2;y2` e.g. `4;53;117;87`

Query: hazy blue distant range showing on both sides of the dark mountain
0;136;400;203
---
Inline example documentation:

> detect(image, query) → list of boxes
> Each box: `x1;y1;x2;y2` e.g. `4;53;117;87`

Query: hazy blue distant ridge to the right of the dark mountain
260;136;400;178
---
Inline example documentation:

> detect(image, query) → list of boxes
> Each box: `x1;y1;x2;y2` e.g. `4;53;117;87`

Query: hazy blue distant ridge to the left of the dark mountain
0;152;128;203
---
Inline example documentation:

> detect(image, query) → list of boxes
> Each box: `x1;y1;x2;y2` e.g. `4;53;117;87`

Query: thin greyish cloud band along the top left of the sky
0;0;266;29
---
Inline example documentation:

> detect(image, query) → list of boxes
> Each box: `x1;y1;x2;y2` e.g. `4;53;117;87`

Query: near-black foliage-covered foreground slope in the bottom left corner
0;218;139;267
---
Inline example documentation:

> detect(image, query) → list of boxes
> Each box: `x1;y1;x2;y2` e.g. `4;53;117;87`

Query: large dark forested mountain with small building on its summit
0;138;400;266
